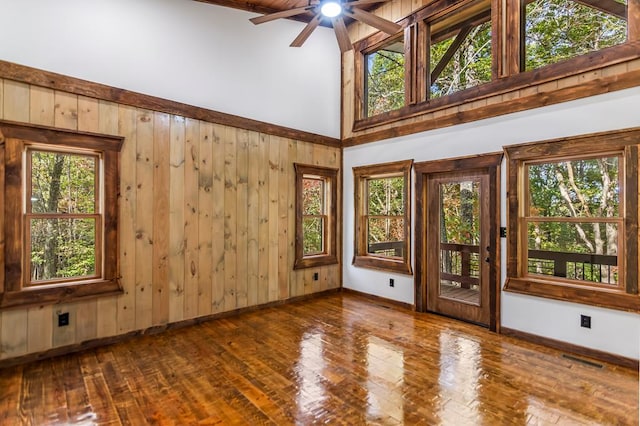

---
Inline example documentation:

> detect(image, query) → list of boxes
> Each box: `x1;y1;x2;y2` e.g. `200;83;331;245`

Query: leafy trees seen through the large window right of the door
527;156;620;282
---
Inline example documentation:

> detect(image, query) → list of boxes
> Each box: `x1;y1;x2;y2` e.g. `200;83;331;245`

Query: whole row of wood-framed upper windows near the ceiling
352;0;640;131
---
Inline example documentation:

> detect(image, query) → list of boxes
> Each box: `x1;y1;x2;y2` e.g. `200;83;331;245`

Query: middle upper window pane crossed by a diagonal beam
428;0;493;99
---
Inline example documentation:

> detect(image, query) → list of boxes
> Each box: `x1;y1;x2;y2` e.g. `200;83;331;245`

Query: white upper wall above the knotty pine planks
0;0;340;137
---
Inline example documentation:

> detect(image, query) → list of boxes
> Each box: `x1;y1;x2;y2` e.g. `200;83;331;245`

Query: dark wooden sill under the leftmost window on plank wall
0;280;123;309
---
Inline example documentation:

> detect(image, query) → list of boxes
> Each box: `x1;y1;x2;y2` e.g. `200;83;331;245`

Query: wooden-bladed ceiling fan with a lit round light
250;0;402;53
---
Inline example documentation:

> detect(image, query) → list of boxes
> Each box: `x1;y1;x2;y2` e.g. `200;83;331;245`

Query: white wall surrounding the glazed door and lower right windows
343;87;640;359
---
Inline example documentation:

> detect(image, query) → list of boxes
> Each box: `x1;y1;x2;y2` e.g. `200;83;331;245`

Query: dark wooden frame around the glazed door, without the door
414;152;503;332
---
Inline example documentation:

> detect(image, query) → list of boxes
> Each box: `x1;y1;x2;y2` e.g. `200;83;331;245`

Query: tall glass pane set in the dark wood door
439;180;480;305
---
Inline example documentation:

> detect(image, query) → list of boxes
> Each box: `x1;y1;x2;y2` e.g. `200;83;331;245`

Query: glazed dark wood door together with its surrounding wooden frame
416;154;501;329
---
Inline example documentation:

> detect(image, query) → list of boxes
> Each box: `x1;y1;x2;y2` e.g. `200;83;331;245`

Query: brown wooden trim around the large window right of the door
504;128;640;312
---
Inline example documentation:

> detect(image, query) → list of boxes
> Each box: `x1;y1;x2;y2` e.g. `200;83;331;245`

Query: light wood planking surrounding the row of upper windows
342;0;640;146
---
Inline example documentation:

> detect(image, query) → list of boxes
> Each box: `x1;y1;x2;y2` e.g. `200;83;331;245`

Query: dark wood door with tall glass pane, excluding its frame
426;172;491;326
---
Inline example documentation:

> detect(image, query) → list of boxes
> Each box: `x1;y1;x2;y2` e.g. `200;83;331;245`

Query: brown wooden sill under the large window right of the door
504;278;640;312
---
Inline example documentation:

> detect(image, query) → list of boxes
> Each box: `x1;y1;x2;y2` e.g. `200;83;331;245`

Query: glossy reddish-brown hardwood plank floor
0;293;638;426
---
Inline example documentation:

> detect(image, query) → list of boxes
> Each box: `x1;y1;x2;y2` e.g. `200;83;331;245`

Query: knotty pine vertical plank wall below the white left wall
0;79;342;359
